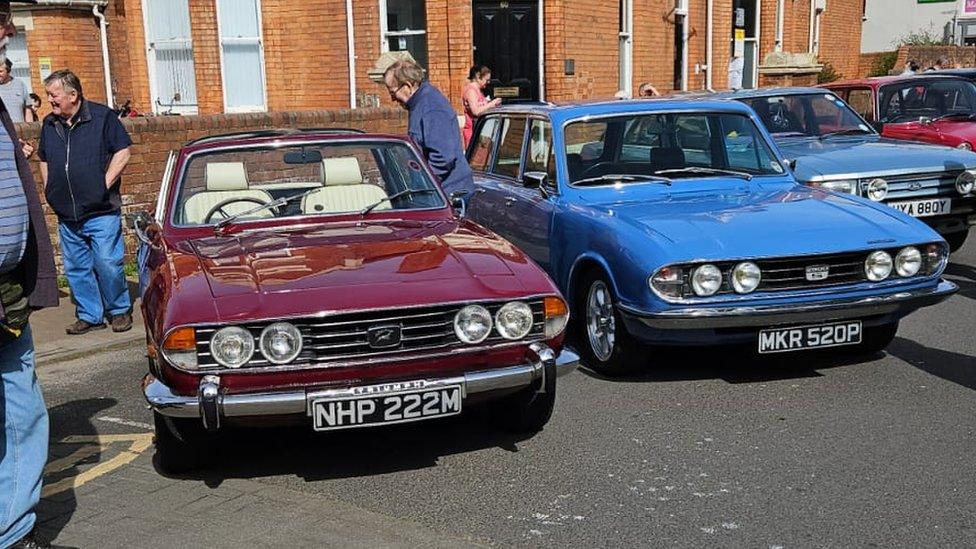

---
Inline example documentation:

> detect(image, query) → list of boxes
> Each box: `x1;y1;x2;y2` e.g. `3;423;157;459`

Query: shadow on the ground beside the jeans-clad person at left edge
37;398;118;542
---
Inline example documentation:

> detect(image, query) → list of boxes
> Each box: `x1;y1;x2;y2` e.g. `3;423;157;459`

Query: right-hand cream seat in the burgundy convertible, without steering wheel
302;156;390;214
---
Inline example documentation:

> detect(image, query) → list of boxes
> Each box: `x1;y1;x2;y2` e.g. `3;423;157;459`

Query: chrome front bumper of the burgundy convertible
142;344;579;430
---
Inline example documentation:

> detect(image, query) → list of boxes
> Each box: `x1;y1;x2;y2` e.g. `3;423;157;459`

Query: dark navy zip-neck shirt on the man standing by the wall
37;99;132;221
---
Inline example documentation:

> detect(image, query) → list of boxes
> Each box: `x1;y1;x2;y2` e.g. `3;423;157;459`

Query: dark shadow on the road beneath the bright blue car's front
580;346;882;384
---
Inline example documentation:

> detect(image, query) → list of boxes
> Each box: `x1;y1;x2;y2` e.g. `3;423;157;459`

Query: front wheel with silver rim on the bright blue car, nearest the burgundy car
574;271;649;377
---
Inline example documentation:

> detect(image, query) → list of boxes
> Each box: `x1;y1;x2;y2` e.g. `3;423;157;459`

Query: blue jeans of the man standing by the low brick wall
58;214;132;324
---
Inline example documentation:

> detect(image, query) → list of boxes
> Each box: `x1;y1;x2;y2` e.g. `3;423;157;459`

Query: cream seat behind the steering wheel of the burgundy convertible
183;162;274;225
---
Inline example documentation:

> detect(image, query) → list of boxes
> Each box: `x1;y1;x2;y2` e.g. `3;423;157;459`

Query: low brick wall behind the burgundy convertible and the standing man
17;108;407;268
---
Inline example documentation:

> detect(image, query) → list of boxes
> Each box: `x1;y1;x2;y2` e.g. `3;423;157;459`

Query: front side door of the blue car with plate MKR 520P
502;118;557;272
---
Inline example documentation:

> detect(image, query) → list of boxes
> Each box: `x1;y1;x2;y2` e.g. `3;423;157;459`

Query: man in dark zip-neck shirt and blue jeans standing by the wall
38;70;132;335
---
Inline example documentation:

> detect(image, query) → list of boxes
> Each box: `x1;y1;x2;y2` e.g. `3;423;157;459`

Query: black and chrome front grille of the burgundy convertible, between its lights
196;299;545;368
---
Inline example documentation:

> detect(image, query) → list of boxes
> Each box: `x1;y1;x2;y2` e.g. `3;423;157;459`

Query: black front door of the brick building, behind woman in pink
474;0;539;103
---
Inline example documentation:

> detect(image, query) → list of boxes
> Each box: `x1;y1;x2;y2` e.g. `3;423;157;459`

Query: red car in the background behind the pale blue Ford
823;74;976;150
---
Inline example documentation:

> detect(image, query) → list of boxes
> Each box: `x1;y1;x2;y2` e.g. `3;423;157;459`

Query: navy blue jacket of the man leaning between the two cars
407;81;473;192
